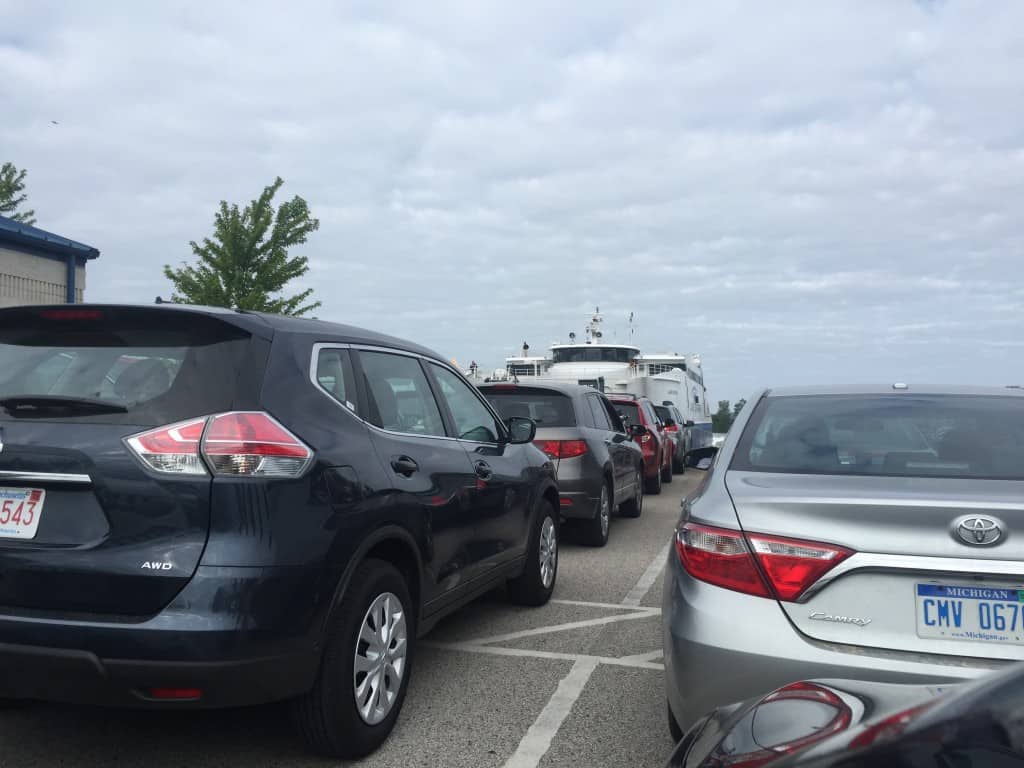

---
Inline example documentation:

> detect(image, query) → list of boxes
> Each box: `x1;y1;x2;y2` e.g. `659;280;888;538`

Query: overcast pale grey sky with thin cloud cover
0;0;1024;400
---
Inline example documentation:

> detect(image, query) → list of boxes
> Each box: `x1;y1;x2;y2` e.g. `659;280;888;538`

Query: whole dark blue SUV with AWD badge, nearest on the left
0;304;558;757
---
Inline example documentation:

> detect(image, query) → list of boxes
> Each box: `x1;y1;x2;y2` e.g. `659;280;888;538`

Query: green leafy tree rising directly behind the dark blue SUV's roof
164;177;321;315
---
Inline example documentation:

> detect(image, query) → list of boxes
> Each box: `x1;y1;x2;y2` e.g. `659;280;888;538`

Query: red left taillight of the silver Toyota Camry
676;522;853;602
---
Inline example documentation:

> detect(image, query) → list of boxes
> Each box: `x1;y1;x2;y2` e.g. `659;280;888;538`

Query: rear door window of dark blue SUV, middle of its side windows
359;352;444;436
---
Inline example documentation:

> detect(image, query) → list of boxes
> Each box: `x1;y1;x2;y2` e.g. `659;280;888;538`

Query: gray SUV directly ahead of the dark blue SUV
480;382;643;547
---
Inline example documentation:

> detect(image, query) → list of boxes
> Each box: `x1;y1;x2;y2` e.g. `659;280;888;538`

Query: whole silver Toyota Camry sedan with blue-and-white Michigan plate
663;384;1024;737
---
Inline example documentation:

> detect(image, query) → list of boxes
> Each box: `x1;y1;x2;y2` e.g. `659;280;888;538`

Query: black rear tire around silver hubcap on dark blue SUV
292;559;416;759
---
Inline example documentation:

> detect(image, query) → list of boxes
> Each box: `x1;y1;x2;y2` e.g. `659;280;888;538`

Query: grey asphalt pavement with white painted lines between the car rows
0;470;700;768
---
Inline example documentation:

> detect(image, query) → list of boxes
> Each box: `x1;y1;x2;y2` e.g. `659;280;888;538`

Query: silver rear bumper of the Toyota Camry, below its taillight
662;550;1011;731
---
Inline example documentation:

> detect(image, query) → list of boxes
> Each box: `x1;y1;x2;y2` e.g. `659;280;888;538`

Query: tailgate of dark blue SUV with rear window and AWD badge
0;307;268;616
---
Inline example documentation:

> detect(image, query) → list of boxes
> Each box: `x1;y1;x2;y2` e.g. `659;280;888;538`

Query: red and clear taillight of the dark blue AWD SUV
125;411;313;477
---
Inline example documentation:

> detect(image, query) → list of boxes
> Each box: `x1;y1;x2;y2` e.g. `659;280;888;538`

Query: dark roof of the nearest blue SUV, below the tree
0;302;447;362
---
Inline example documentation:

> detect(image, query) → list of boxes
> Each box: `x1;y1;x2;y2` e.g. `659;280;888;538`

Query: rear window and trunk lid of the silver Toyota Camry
726;396;1024;659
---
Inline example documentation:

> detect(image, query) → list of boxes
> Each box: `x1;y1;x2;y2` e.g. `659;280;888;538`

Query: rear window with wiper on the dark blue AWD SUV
0;310;249;424
